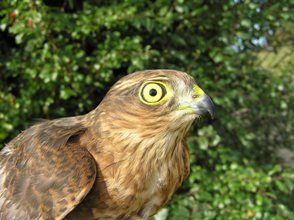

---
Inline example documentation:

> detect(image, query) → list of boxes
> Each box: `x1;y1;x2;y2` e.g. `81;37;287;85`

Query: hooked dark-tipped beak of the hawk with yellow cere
191;93;214;119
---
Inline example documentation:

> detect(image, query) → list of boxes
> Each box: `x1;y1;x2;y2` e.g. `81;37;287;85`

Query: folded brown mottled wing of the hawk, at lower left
0;118;96;220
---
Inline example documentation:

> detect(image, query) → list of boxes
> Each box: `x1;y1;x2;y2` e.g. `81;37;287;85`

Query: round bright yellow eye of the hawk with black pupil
140;82;167;105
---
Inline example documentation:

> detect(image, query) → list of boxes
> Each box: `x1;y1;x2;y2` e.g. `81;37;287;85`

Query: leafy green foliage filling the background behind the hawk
0;0;294;220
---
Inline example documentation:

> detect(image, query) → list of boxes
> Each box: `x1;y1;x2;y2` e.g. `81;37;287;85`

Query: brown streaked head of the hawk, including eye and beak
98;70;214;137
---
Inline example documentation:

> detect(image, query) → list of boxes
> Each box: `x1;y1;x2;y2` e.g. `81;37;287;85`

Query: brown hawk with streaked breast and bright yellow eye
0;70;213;220
